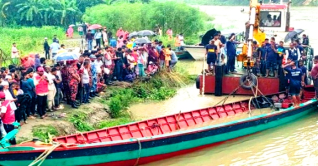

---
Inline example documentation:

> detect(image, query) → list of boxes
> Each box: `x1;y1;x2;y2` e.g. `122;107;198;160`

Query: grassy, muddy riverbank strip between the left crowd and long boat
17;62;195;142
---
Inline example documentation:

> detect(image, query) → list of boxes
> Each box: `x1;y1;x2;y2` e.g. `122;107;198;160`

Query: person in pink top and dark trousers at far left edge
0;92;17;145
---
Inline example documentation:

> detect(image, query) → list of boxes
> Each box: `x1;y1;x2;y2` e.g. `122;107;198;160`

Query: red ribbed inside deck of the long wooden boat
53;89;314;144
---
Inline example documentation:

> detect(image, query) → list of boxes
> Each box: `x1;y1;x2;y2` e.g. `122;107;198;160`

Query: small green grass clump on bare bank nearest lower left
32;125;58;142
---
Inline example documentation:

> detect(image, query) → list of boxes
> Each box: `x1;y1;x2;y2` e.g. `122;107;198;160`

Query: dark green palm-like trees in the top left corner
0;0;84;26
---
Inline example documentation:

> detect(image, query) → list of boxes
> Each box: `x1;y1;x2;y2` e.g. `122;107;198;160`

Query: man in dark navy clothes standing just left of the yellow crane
226;33;238;73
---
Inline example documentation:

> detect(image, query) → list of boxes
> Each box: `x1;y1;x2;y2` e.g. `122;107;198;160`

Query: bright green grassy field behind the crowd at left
0;26;65;65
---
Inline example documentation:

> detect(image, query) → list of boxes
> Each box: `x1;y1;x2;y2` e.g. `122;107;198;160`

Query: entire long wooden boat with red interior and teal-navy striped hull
0;87;318;166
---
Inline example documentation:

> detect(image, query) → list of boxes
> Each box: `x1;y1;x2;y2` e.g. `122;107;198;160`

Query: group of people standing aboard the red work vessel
206;33;312;106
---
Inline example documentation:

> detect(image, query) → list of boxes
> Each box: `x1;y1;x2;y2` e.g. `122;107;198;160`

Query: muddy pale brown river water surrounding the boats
129;6;318;166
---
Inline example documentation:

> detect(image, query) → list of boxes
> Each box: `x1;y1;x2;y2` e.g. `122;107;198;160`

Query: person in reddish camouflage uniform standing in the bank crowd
67;60;81;108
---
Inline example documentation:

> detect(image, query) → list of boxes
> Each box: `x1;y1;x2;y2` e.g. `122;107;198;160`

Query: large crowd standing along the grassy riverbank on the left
0;25;178;141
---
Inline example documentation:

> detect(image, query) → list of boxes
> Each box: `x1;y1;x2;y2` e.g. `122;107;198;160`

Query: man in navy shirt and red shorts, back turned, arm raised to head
282;59;305;107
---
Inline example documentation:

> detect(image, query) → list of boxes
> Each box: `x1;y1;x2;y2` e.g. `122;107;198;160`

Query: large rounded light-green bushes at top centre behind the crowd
83;2;205;36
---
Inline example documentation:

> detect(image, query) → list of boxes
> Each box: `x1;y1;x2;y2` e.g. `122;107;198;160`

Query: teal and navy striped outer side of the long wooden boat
0;100;317;166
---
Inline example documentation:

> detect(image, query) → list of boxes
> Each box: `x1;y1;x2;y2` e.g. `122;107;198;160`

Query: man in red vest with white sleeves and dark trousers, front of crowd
34;66;49;119
